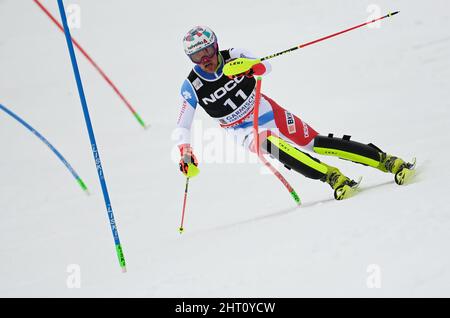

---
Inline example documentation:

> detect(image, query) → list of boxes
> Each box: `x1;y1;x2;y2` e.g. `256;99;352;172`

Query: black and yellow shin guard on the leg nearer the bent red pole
262;135;328;179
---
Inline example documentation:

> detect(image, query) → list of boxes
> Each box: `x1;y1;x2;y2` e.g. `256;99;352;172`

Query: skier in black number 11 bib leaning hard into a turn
177;26;413;200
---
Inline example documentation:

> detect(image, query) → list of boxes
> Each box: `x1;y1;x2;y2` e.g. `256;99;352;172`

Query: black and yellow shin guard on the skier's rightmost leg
313;134;382;167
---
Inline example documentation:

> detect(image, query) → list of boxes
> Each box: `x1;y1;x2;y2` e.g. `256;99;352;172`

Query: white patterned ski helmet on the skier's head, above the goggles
183;26;217;57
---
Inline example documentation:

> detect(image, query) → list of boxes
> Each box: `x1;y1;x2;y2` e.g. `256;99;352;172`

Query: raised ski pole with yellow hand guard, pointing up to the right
223;11;400;76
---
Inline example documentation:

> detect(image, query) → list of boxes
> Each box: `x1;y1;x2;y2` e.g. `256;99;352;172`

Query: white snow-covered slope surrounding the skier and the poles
0;0;450;297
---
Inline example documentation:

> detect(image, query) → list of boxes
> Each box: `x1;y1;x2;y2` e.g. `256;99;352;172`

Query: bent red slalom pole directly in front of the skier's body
253;76;301;205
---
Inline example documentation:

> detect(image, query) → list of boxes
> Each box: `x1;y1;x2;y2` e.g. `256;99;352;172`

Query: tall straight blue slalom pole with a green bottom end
58;0;127;273
